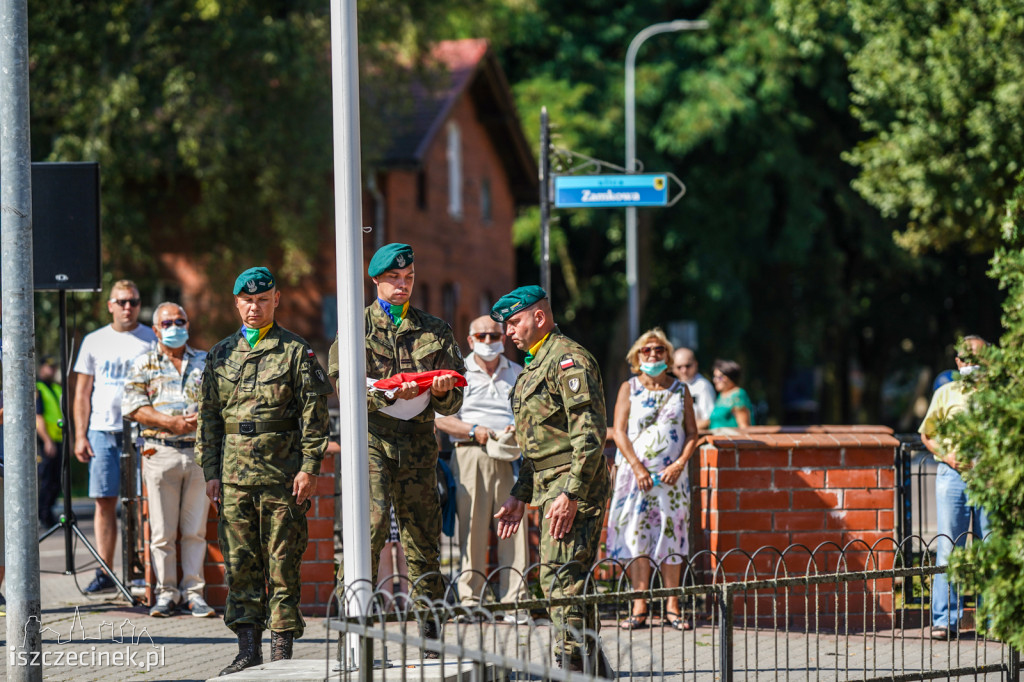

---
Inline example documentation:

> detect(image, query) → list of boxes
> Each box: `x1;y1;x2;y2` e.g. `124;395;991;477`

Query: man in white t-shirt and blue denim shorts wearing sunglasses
74;280;157;594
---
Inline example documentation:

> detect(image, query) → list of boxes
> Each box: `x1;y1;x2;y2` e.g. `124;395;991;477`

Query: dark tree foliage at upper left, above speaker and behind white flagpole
24;0;487;292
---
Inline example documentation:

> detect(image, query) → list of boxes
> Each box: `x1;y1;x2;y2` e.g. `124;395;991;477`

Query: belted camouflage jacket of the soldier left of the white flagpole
196;324;332;485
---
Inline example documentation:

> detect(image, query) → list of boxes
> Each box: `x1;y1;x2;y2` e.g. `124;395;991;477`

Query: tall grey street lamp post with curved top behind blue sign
625;19;708;343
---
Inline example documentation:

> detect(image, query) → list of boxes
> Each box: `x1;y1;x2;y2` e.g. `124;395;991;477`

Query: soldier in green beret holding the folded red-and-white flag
328;244;466;636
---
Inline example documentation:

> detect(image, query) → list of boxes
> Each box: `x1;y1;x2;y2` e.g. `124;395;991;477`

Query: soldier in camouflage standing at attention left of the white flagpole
196;267;332;675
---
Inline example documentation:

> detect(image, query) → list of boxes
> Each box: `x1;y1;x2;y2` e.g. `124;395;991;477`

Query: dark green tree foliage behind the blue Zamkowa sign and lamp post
495;0;997;423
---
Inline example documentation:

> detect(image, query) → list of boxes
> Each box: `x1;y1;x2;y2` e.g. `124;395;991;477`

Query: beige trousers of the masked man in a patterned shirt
142;441;210;604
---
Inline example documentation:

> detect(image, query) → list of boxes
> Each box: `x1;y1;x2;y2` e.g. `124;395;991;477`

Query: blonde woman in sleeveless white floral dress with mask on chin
607;328;697;630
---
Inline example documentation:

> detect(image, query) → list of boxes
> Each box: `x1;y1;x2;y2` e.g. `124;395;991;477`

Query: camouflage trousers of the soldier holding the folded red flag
338;452;444;601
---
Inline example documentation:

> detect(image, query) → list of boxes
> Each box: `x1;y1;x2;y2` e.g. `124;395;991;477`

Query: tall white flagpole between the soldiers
331;0;374;674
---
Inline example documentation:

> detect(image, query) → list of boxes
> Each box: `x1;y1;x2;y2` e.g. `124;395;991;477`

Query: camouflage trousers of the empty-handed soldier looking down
540;500;606;658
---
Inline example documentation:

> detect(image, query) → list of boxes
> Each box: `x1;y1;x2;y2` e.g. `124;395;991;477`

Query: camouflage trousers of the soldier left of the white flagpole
217;483;309;637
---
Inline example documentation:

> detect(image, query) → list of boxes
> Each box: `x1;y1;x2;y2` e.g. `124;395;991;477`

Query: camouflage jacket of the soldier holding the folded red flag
328;301;466;468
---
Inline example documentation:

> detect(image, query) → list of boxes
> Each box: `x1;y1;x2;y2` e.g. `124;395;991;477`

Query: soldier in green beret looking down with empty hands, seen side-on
490;286;611;671
